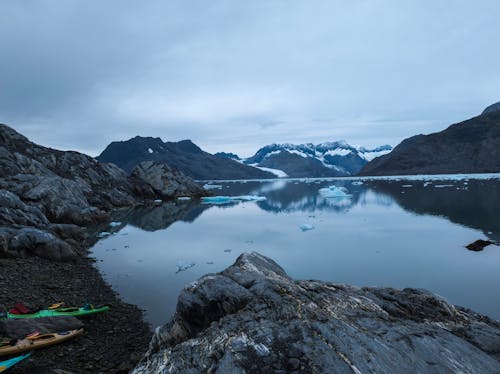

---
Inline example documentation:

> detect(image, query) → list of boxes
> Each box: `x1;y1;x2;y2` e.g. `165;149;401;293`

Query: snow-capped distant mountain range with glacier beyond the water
244;141;392;177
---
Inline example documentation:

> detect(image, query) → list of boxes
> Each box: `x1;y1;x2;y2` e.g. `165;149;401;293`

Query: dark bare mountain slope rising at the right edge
360;104;500;175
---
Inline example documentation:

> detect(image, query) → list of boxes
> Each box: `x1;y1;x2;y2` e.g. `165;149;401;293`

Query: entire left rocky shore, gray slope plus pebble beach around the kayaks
0;125;206;373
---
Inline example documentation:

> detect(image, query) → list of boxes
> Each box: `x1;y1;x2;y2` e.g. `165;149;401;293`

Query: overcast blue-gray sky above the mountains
0;0;500;157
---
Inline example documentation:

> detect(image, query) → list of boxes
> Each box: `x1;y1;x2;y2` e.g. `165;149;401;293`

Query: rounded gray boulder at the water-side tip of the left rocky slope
131;161;206;199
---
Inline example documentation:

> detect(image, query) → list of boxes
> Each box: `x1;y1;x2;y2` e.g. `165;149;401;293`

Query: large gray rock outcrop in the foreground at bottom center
133;253;500;374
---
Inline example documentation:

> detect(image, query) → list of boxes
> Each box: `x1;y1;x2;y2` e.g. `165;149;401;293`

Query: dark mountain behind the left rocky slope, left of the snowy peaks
97;136;274;179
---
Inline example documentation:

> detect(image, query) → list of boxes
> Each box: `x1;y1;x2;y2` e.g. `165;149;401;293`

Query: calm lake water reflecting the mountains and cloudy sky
92;175;500;326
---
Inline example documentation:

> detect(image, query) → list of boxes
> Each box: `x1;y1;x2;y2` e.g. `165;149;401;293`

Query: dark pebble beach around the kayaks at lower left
0;251;152;374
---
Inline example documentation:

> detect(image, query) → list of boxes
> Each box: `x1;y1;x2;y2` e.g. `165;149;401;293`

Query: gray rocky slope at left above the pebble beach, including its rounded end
0;125;203;261
